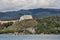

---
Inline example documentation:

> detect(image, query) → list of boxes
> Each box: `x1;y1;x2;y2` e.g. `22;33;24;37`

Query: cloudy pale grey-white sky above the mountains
0;0;60;12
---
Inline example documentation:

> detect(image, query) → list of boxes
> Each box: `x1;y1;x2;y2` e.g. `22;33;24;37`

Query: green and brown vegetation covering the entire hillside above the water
0;16;60;34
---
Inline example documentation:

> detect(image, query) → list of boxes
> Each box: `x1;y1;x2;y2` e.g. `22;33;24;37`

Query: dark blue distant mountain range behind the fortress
0;8;60;19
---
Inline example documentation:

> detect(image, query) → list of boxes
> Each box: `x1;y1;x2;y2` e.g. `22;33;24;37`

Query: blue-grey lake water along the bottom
0;34;60;40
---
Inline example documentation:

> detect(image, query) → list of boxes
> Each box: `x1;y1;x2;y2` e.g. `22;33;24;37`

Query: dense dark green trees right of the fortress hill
36;16;60;34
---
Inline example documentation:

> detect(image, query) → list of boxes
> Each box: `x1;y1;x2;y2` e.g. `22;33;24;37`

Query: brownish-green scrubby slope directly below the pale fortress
12;20;37;32
